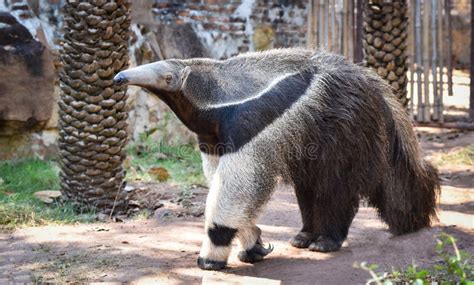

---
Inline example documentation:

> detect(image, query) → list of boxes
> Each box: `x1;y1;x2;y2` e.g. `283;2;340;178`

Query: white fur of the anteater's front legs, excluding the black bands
199;153;276;262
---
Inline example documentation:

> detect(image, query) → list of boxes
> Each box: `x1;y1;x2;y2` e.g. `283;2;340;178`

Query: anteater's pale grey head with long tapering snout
114;60;190;94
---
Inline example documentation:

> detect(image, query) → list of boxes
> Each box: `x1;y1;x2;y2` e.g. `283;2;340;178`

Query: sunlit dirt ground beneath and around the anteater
0;128;474;284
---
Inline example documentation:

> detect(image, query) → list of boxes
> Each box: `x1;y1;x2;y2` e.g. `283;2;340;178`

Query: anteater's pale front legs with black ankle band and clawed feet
198;159;274;270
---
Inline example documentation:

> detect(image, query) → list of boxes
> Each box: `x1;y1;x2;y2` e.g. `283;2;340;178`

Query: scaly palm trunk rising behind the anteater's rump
364;0;408;106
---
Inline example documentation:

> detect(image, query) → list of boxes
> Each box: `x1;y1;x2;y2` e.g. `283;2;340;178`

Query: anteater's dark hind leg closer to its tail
309;189;359;252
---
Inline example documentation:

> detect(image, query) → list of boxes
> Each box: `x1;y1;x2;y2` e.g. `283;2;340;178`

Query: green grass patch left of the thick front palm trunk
0;159;94;230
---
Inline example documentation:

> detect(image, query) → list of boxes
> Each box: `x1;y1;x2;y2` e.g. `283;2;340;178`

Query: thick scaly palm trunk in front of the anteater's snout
59;0;130;214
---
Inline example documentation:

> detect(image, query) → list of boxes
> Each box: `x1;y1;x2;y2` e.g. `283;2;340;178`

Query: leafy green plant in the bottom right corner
354;233;474;285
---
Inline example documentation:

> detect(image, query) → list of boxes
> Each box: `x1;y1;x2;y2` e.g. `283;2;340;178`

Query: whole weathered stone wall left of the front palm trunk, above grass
0;1;59;159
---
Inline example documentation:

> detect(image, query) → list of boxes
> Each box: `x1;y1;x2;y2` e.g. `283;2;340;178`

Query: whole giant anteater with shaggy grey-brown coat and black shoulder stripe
115;49;439;269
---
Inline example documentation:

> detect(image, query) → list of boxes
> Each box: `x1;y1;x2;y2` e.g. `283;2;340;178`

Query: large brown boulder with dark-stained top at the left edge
0;12;55;135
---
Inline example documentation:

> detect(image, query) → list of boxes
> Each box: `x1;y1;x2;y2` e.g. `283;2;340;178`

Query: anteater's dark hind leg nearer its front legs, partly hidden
290;186;316;248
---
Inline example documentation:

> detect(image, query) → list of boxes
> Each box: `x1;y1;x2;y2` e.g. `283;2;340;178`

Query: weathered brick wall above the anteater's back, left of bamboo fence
152;0;307;59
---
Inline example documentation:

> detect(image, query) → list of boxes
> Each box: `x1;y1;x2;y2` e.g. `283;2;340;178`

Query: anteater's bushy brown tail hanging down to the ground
370;96;440;235
